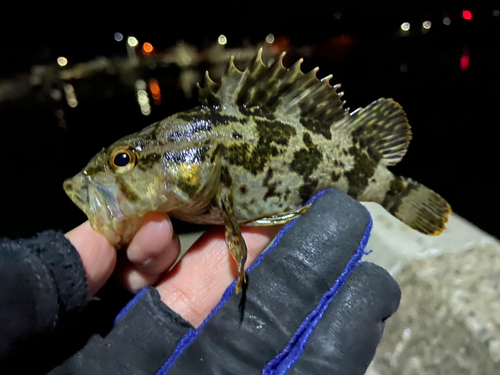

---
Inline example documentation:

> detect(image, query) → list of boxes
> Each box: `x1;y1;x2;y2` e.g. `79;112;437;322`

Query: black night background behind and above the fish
0;1;500;237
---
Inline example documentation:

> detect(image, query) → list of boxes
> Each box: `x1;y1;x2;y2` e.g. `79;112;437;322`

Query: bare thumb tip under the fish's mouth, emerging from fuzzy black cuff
65;221;116;296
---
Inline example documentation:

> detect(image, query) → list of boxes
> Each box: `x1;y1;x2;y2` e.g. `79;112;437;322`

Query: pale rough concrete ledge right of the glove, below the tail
365;203;500;375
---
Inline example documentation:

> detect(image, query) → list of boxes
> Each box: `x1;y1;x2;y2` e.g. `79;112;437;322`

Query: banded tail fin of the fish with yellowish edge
382;177;451;236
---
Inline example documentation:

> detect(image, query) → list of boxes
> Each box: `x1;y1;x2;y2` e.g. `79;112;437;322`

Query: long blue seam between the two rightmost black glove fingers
262;210;373;375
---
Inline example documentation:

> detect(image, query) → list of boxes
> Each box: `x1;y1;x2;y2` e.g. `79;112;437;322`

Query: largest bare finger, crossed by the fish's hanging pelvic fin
157;226;282;327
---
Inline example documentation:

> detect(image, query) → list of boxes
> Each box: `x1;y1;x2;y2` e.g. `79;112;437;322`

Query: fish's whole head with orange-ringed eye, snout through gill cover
63;115;221;246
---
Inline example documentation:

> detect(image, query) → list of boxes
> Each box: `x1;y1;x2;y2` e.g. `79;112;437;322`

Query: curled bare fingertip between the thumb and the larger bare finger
115;212;180;293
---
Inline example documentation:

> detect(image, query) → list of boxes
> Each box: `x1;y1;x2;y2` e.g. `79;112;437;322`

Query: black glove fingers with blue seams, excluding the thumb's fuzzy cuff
53;190;400;375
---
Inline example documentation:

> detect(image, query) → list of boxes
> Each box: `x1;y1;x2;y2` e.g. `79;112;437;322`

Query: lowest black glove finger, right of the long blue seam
287;263;401;375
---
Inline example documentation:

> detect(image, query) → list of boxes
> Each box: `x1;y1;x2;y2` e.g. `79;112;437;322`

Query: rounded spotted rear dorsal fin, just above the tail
342;98;411;165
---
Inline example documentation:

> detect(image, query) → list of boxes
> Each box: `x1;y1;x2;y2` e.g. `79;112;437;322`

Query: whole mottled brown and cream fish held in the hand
63;49;451;292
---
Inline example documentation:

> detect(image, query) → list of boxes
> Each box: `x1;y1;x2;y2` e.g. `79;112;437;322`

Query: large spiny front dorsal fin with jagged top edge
199;48;348;137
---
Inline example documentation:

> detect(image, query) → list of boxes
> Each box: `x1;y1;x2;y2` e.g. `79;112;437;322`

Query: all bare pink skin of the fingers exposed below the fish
66;206;283;327
